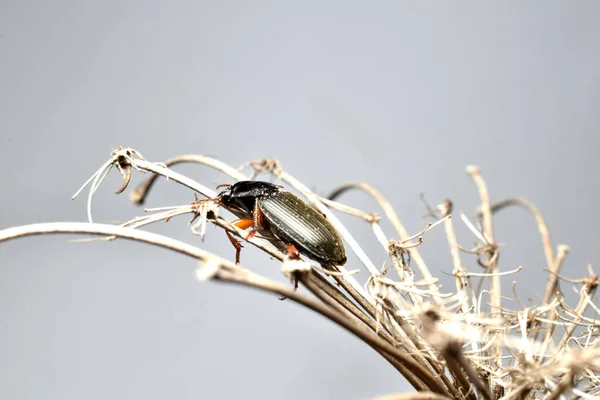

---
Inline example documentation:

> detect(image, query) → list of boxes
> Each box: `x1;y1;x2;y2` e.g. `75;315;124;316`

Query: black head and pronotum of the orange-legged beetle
218;181;281;218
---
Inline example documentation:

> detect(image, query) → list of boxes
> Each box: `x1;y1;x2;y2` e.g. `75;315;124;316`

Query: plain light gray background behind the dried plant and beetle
0;0;600;399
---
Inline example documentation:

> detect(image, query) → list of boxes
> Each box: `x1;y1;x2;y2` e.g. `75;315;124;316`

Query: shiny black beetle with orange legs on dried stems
216;181;346;267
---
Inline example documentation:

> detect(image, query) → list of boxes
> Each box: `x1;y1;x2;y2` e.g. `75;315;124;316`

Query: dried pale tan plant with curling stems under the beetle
0;148;600;400
